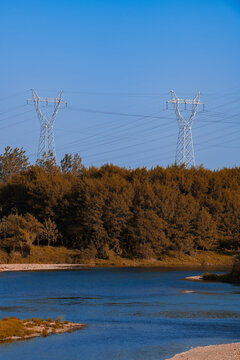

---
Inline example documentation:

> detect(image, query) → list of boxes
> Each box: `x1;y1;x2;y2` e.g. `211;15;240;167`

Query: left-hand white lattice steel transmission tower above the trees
27;89;67;159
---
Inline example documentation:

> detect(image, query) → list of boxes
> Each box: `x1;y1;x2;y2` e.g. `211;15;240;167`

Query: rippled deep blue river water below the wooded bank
0;268;240;360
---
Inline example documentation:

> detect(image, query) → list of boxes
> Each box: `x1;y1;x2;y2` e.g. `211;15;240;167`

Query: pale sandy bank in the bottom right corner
166;343;240;360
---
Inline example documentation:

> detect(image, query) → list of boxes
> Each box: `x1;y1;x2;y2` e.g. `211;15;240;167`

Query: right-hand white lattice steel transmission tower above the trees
167;90;204;169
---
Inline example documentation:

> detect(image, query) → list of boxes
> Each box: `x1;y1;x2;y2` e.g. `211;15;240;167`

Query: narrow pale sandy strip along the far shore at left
0;264;94;272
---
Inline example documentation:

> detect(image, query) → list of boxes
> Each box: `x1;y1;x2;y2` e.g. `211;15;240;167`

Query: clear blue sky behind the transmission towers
0;0;240;169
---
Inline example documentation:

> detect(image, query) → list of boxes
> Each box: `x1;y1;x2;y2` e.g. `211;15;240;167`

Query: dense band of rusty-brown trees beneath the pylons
0;147;240;259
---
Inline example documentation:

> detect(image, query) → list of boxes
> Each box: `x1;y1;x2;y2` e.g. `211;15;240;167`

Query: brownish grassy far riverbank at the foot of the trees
0;246;235;271
